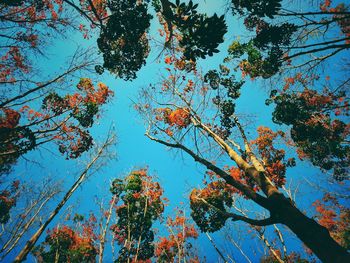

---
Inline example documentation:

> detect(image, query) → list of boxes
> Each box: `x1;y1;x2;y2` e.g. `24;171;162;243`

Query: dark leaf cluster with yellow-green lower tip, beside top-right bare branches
229;0;297;78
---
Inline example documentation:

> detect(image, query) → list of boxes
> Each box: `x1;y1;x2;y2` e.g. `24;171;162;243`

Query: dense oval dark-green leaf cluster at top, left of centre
97;0;152;80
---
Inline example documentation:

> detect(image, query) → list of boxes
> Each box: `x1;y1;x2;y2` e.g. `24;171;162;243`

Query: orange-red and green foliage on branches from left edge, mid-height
0;78;113;163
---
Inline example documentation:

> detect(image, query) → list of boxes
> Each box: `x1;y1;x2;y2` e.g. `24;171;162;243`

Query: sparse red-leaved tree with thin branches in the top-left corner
0;0;72;88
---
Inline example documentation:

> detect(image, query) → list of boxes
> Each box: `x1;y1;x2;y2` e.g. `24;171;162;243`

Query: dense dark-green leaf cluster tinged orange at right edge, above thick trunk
268;90;350;180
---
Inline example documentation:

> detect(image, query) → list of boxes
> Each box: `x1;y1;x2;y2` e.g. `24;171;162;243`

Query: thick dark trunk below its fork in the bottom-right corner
271;195;350;263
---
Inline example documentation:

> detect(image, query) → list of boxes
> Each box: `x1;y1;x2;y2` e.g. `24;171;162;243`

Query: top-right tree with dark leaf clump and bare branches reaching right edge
228;0;350;78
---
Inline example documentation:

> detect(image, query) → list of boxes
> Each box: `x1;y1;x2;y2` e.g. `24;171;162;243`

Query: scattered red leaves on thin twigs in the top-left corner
0;0;67;83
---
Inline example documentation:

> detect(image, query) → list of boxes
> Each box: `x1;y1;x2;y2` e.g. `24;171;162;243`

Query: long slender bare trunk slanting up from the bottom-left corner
13;140;110;263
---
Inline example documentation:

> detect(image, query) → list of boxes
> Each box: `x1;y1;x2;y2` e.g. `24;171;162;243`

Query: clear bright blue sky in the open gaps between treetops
3;1;350;262
